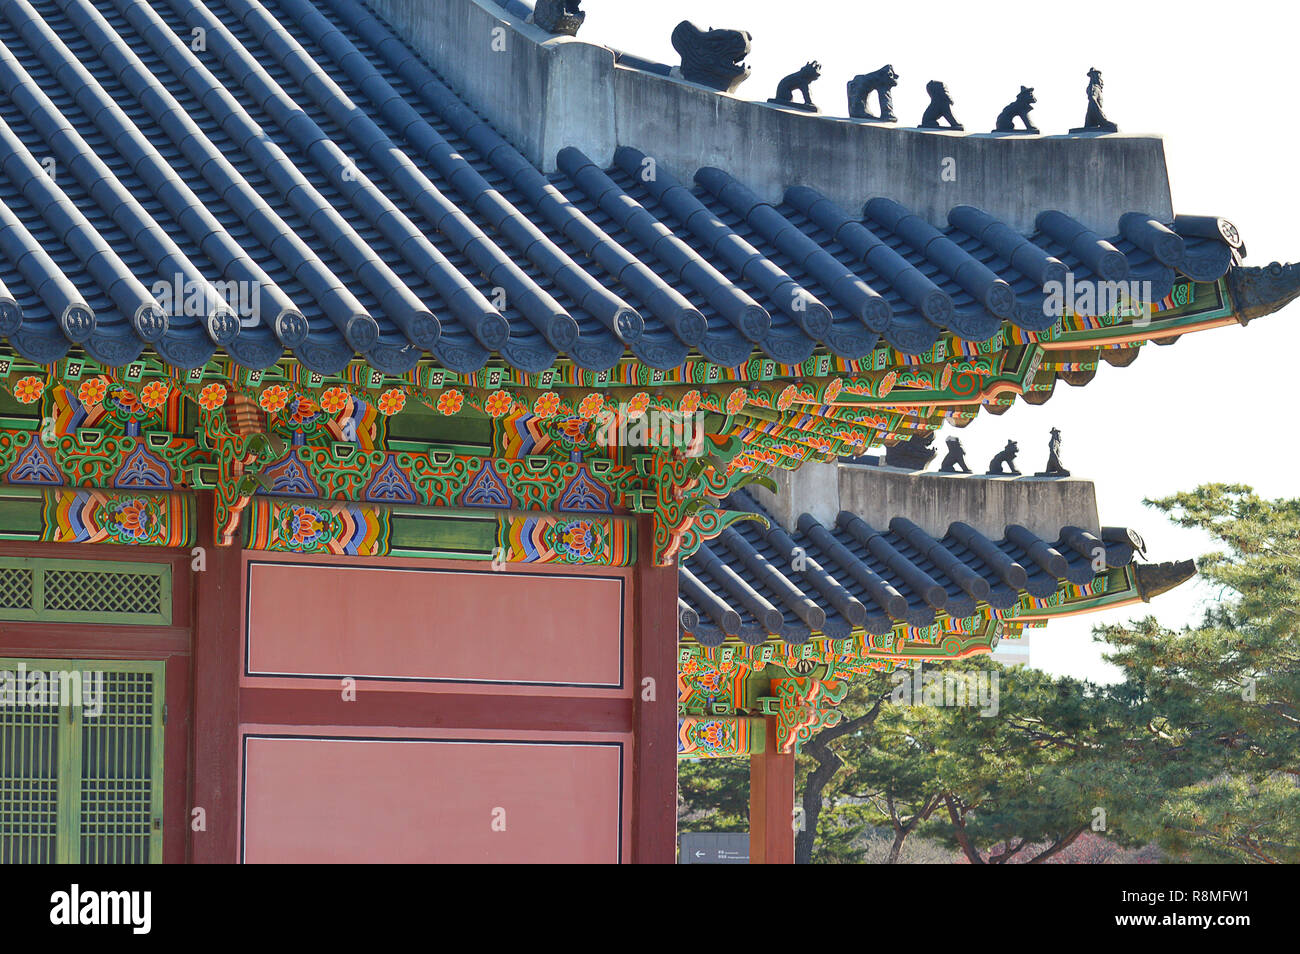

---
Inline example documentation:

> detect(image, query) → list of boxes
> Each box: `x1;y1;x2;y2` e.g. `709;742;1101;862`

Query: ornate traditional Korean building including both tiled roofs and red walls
0;0;1300;862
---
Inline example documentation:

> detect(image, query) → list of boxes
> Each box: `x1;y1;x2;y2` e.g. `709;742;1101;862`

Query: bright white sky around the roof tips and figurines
581;0;1300;680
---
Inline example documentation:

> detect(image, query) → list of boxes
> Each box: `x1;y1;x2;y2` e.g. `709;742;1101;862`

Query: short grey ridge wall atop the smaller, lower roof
750;463;1101;541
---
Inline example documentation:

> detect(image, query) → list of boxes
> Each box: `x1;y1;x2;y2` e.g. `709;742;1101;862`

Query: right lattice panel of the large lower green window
81;672;155;864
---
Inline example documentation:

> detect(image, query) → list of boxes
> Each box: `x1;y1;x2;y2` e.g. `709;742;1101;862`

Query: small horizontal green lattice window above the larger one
0;558;172;626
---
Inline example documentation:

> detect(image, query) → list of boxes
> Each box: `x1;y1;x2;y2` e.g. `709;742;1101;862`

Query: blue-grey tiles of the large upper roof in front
0;0;1236;373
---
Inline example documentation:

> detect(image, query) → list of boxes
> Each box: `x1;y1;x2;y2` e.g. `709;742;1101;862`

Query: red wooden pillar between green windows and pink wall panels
189;491;243;863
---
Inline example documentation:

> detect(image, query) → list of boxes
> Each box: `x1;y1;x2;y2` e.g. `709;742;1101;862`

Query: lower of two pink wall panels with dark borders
243;736;625;863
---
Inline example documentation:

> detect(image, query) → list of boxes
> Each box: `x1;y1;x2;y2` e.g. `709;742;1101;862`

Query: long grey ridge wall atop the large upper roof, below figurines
365;0;1173;235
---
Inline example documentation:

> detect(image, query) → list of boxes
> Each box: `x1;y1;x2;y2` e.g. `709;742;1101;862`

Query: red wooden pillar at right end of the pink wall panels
632;517;677;864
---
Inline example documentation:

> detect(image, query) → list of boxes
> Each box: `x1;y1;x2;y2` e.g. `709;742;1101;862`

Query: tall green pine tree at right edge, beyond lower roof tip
1097;483;1300;863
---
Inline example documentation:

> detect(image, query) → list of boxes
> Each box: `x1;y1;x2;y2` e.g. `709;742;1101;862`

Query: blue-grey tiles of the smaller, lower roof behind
677;491;1149;646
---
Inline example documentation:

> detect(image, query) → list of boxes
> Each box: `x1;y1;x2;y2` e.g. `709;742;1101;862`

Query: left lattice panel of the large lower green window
0;671;62;864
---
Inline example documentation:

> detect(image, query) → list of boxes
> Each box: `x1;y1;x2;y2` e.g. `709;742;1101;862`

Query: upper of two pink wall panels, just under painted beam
244;560;627;689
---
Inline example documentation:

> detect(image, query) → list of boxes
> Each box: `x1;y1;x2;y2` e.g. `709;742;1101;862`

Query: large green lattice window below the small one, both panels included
0;659;165;864
